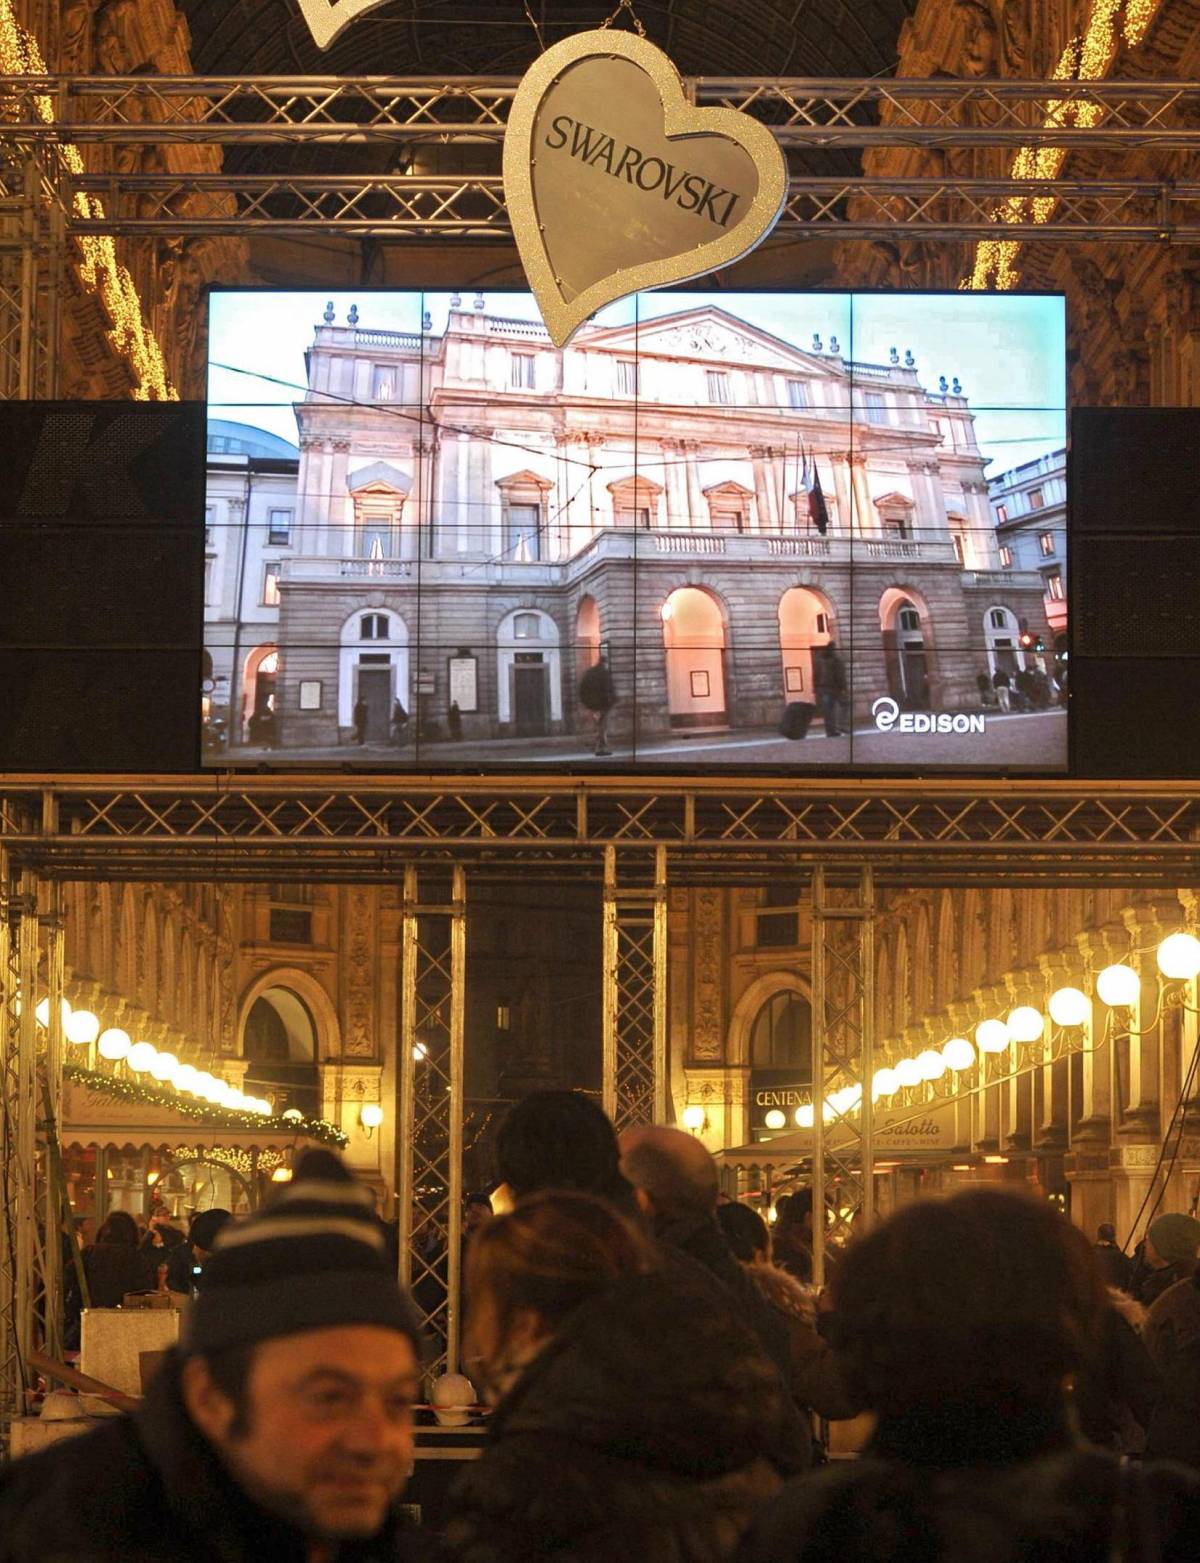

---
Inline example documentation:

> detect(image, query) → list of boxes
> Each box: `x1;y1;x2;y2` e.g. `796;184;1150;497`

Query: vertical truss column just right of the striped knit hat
397;864;467;1374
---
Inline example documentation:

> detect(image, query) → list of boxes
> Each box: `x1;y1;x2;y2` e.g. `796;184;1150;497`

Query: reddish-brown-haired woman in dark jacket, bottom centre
444;1191;795;1563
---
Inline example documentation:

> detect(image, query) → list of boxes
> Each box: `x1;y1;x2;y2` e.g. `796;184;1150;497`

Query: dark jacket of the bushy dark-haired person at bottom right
739;1408;1200;1563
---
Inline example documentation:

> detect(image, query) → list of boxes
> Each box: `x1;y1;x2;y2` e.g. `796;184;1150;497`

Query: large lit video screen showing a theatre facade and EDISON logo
203;292;1067;771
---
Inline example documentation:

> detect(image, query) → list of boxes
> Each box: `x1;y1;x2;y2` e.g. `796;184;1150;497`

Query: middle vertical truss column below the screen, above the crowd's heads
603;847;667;1133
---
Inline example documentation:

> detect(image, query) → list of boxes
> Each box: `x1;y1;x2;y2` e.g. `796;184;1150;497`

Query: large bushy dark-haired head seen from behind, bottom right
834;1188;1105;1416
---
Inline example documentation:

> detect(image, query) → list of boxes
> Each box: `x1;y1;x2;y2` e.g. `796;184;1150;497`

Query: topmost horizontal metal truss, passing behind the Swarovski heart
0;75;1200;150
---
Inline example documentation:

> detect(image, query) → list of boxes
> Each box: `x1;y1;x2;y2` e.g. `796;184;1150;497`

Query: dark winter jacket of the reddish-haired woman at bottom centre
444;1275;794;1563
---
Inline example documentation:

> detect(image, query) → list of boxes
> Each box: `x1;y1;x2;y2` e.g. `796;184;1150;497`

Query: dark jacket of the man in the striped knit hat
0;1350;423;1563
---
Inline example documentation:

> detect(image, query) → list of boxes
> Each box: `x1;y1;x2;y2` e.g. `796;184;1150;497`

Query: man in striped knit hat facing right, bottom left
0;1157;422;1563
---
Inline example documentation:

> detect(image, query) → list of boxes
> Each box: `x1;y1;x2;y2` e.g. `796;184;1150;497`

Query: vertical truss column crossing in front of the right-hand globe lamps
813;867;875;1285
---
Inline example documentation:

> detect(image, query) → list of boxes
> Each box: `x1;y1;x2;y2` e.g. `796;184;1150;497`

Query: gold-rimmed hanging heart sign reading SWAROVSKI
505;30;788;347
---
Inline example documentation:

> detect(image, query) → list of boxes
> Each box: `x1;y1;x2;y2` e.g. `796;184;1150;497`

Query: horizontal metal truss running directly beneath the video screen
0;777;1200;886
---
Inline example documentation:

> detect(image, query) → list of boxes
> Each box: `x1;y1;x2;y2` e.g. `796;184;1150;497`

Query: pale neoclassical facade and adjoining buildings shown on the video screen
208;297;1045;749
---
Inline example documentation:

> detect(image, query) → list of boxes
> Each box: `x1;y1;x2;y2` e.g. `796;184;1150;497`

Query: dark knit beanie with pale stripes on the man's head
180;1155;420;1355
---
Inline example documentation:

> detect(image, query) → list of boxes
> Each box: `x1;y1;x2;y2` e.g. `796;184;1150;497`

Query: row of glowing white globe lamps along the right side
743;933;1200;1130
